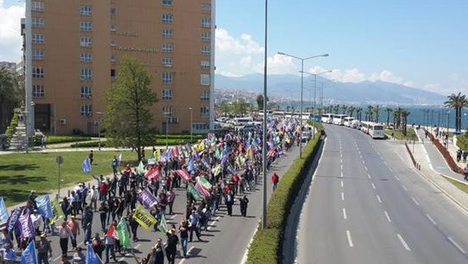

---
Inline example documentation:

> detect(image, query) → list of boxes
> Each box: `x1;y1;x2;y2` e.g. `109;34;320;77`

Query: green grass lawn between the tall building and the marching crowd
0;150;147;206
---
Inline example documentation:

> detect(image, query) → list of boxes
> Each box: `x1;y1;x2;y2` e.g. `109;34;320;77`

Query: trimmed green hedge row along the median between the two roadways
247;124;325;264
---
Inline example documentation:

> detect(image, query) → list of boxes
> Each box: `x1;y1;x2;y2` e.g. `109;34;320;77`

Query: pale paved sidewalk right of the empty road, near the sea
410;129;468;212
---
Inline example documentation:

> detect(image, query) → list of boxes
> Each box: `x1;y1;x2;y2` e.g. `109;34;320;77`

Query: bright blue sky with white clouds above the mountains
0;0;468;95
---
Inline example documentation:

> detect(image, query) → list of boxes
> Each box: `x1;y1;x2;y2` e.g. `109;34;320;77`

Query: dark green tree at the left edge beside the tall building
0;67;22;134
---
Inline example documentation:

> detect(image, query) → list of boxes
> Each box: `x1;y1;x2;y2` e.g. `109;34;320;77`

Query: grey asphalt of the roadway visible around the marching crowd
44;147;299;264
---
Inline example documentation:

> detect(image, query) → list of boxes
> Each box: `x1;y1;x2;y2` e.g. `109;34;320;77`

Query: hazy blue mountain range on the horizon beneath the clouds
215;74;447;105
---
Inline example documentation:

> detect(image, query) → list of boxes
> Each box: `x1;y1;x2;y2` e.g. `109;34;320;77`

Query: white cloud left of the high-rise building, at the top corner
0;0;25;62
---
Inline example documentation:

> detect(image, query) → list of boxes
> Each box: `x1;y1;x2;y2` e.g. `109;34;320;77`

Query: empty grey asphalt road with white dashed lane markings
295;125;468;264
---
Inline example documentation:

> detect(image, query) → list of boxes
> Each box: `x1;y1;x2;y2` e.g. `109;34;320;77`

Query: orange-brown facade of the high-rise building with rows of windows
30;0;215;134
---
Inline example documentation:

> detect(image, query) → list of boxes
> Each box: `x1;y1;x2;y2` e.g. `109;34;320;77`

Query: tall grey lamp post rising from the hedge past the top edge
262;0;268;229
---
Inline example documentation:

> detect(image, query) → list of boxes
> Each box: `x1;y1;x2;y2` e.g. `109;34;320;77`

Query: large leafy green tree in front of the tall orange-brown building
104;57;157;161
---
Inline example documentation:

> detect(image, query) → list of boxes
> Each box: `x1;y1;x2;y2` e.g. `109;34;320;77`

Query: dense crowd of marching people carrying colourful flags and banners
0;116;300;264
